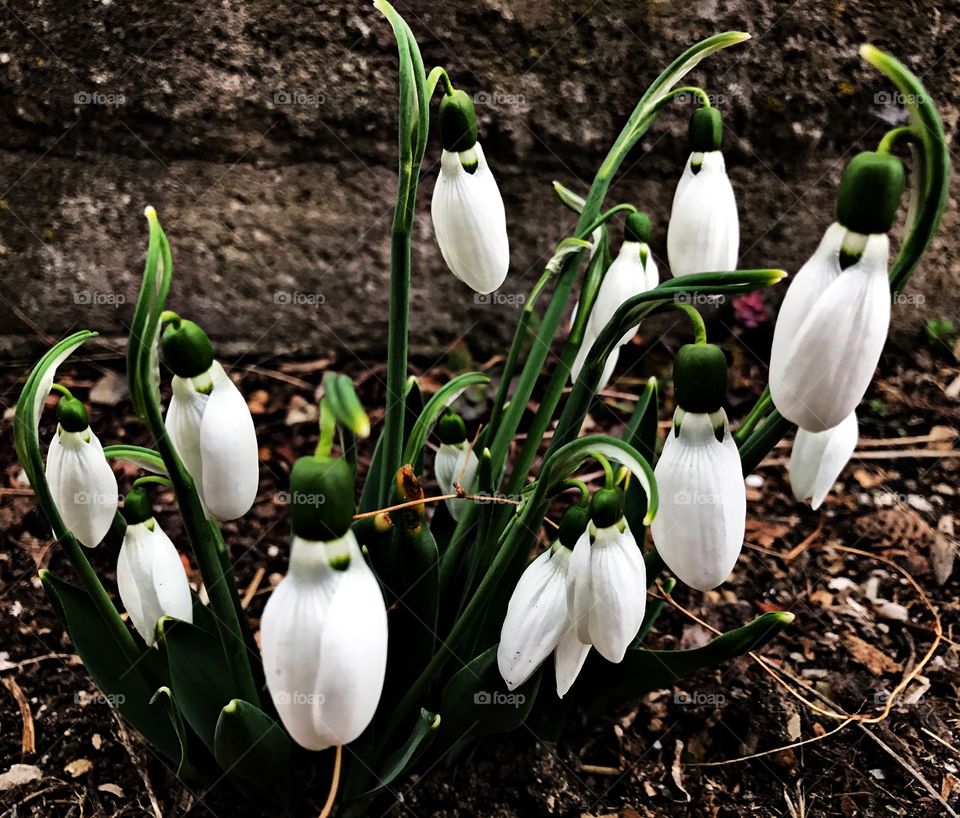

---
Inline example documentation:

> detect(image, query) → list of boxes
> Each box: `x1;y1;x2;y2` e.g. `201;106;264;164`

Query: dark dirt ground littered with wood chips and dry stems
0;324;960;818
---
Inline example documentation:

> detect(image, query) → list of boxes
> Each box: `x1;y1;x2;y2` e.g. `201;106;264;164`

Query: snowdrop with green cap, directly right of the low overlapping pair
651;344;747;591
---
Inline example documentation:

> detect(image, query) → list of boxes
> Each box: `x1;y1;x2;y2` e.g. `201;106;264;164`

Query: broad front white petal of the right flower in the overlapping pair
588;521;647;663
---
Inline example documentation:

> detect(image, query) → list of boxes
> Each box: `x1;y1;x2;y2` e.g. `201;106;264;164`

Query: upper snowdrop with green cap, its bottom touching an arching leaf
667;108;740;276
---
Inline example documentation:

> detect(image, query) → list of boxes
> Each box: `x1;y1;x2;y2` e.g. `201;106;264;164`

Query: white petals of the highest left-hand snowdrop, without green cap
166;361;260;520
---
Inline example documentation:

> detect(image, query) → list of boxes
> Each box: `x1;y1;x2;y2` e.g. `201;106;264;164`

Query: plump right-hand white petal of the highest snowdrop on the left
200;361;260;520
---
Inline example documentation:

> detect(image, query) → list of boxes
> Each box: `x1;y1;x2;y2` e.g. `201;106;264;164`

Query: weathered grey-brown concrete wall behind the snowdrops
0;0;960;358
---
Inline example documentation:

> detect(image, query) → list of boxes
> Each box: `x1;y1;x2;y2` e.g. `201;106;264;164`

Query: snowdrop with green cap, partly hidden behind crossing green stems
570;213;660;391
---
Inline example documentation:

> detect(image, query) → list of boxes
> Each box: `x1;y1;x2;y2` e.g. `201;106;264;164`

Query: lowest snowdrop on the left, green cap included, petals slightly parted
117;487;193;646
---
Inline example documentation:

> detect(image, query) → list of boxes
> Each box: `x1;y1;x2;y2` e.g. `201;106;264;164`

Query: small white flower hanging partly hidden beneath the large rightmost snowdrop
790;412;859;510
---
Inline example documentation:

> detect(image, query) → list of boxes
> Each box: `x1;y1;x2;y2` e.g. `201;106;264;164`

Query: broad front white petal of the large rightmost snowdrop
770;235;890;432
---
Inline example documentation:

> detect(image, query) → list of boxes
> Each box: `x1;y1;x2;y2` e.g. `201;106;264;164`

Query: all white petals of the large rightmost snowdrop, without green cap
770;223;890;432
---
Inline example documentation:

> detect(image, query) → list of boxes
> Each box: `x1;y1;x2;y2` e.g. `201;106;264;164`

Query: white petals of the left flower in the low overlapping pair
497;541;590;698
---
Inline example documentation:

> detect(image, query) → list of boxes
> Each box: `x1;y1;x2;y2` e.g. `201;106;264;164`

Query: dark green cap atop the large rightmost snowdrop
837;151;905;235
